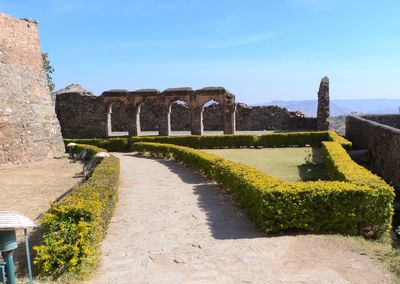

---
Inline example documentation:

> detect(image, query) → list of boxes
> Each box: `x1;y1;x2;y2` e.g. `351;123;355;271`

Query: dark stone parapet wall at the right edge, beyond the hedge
346;115;400;189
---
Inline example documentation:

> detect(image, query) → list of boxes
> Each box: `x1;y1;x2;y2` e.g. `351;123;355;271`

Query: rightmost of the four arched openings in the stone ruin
203;99;224;131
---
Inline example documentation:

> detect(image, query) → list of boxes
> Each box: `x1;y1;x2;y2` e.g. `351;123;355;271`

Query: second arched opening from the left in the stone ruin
136;101;158;136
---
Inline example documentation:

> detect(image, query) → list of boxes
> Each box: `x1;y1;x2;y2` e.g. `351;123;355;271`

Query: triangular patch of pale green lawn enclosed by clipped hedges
204;147;327;181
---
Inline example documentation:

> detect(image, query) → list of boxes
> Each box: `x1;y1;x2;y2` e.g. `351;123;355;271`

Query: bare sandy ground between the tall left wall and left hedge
0;158;82;221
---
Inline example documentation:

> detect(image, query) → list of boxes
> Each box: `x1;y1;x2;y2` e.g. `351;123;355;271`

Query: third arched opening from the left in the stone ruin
169;100;191;135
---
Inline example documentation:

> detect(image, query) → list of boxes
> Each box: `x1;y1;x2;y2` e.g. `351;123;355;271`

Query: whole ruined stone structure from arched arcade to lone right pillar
56;77;329;138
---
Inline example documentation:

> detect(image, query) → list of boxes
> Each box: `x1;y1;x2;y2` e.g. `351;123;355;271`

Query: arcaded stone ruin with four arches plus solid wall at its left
56;87;236;138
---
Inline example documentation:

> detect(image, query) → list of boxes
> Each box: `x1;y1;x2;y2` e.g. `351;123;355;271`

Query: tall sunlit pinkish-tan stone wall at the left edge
0;13;64;164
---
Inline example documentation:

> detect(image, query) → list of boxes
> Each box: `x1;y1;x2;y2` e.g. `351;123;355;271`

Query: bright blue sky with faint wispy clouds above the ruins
0;0;400;104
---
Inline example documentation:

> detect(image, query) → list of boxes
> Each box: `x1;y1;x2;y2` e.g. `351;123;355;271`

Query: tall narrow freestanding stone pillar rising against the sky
317;77;329;131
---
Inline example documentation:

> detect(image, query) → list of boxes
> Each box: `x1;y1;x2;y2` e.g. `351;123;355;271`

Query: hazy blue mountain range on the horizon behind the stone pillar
261;99;400;116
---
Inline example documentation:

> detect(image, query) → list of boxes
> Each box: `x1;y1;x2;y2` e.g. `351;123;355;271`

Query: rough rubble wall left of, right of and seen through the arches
56;90;317;138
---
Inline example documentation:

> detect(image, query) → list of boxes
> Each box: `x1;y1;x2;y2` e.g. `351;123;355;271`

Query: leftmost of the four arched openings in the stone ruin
107;102;129;137
